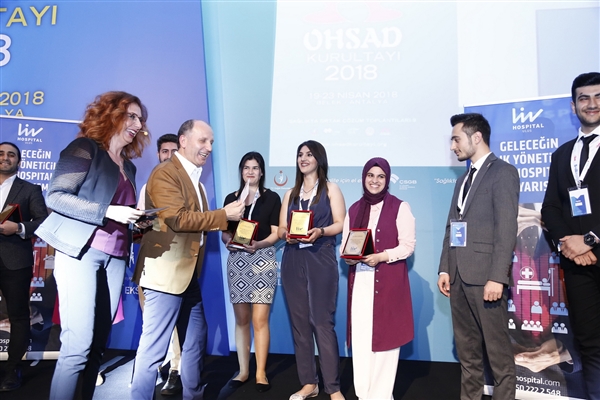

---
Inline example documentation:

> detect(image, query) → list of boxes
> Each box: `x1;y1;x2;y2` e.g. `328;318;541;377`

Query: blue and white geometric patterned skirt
227;246;277;304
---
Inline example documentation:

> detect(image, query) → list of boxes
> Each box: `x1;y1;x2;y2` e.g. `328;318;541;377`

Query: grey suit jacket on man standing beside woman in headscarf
438;153;520;285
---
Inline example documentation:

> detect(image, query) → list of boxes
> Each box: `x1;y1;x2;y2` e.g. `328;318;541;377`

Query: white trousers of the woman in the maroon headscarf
352;271;400;400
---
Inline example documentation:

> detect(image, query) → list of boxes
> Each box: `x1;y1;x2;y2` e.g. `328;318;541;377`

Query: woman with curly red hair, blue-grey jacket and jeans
36;92;150;400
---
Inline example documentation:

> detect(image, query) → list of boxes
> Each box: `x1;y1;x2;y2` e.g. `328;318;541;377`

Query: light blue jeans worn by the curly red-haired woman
50;248;127;400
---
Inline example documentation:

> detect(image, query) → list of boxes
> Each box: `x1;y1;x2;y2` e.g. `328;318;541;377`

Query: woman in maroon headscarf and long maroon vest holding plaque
340;158;416;400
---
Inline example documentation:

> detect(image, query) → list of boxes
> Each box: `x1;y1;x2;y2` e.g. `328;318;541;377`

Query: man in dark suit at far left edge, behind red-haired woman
0;142;48;392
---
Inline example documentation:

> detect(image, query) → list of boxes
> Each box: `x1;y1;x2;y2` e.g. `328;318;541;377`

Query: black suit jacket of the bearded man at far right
542;138;600;267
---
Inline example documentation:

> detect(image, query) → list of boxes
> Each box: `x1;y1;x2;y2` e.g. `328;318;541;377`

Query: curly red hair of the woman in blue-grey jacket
79;92;150;159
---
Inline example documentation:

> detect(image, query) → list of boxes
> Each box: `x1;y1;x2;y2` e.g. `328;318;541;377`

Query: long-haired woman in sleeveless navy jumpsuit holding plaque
278;140;346;400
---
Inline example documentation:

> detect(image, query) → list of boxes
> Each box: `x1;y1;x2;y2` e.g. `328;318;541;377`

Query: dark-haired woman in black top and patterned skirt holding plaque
222;151;281;392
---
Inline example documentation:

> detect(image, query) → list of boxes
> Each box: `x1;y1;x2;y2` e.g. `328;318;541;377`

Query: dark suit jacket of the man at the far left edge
0;177;48;270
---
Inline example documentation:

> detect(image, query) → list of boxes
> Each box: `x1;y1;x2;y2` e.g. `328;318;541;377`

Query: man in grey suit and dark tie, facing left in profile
438;114;519;400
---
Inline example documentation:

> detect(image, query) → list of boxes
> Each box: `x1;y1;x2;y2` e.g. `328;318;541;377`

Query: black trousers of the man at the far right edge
564;265;600;400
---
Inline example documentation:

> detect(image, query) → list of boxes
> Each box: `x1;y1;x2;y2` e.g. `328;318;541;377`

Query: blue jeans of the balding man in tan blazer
131;278;207;400
